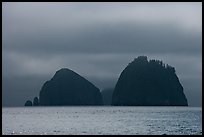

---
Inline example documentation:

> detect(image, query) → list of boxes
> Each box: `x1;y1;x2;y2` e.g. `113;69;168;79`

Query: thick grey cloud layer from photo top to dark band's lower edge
3;3;202;54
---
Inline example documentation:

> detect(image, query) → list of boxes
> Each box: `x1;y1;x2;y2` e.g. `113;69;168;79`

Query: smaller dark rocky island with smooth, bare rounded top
39;68;103;106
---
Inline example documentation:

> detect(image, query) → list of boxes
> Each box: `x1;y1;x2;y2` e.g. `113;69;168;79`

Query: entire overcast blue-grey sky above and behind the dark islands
2;2;202;106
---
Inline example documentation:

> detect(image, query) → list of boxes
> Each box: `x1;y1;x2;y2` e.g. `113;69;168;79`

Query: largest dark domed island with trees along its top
112;56;188;106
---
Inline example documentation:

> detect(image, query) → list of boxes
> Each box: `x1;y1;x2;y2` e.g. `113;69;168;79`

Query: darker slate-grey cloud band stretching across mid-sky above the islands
4;20;202;54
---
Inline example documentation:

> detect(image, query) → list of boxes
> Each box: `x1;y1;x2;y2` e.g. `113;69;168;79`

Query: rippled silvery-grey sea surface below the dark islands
2;106;202;135
